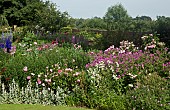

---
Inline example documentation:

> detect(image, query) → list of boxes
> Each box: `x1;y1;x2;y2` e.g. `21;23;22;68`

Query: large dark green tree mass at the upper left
0;0;69;31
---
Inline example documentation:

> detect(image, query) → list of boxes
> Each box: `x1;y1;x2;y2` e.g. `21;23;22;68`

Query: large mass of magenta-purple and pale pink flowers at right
86;35;169;91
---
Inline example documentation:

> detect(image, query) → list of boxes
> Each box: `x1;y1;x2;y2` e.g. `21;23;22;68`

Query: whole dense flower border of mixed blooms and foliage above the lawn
0;29;170;110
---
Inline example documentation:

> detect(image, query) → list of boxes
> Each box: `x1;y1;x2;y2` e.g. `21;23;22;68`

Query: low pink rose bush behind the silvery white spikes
27;64;84;92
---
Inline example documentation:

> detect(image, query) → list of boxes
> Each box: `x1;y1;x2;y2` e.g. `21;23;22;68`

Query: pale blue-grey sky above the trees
51;0;170;19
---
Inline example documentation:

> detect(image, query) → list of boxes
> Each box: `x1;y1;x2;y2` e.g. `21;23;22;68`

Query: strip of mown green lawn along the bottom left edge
0;104;92;110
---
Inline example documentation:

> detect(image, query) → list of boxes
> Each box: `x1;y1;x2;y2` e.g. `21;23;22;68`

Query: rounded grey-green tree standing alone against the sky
104;4;130;31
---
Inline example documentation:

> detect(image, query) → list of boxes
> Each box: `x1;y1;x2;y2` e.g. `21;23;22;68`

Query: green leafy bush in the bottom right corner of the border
126;73;170;110
